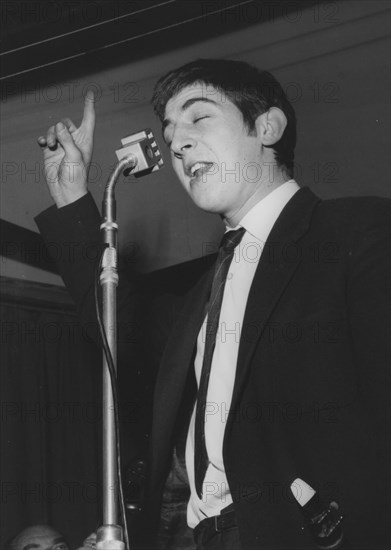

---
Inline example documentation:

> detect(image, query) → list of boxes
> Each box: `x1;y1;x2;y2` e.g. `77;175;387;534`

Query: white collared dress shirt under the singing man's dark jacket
186;180;299;528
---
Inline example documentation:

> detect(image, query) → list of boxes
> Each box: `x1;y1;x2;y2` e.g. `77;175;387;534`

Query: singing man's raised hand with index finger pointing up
38;91;95;208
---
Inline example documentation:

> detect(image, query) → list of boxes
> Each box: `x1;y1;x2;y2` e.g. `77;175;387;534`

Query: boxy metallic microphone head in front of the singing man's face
115;128;163;178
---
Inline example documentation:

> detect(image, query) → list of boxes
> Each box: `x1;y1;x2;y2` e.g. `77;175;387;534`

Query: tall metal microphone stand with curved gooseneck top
96;154;138;550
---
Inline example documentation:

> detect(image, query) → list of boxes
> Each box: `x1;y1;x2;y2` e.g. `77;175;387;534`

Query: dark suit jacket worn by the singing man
37;188;391;550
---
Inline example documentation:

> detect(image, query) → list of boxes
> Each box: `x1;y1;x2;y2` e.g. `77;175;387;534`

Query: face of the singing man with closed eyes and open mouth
163;83;264;223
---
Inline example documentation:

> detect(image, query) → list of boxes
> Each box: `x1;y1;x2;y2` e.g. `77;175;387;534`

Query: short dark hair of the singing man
152;59;296;177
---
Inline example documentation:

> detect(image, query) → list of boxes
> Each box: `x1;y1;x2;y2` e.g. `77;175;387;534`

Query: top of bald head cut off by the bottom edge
9;525;69;550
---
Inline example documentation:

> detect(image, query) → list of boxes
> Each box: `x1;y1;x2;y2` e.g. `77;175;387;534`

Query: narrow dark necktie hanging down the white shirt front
194;227;245;498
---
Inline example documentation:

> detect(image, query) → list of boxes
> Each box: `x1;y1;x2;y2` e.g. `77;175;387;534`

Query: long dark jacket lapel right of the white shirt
226;188;320;436
